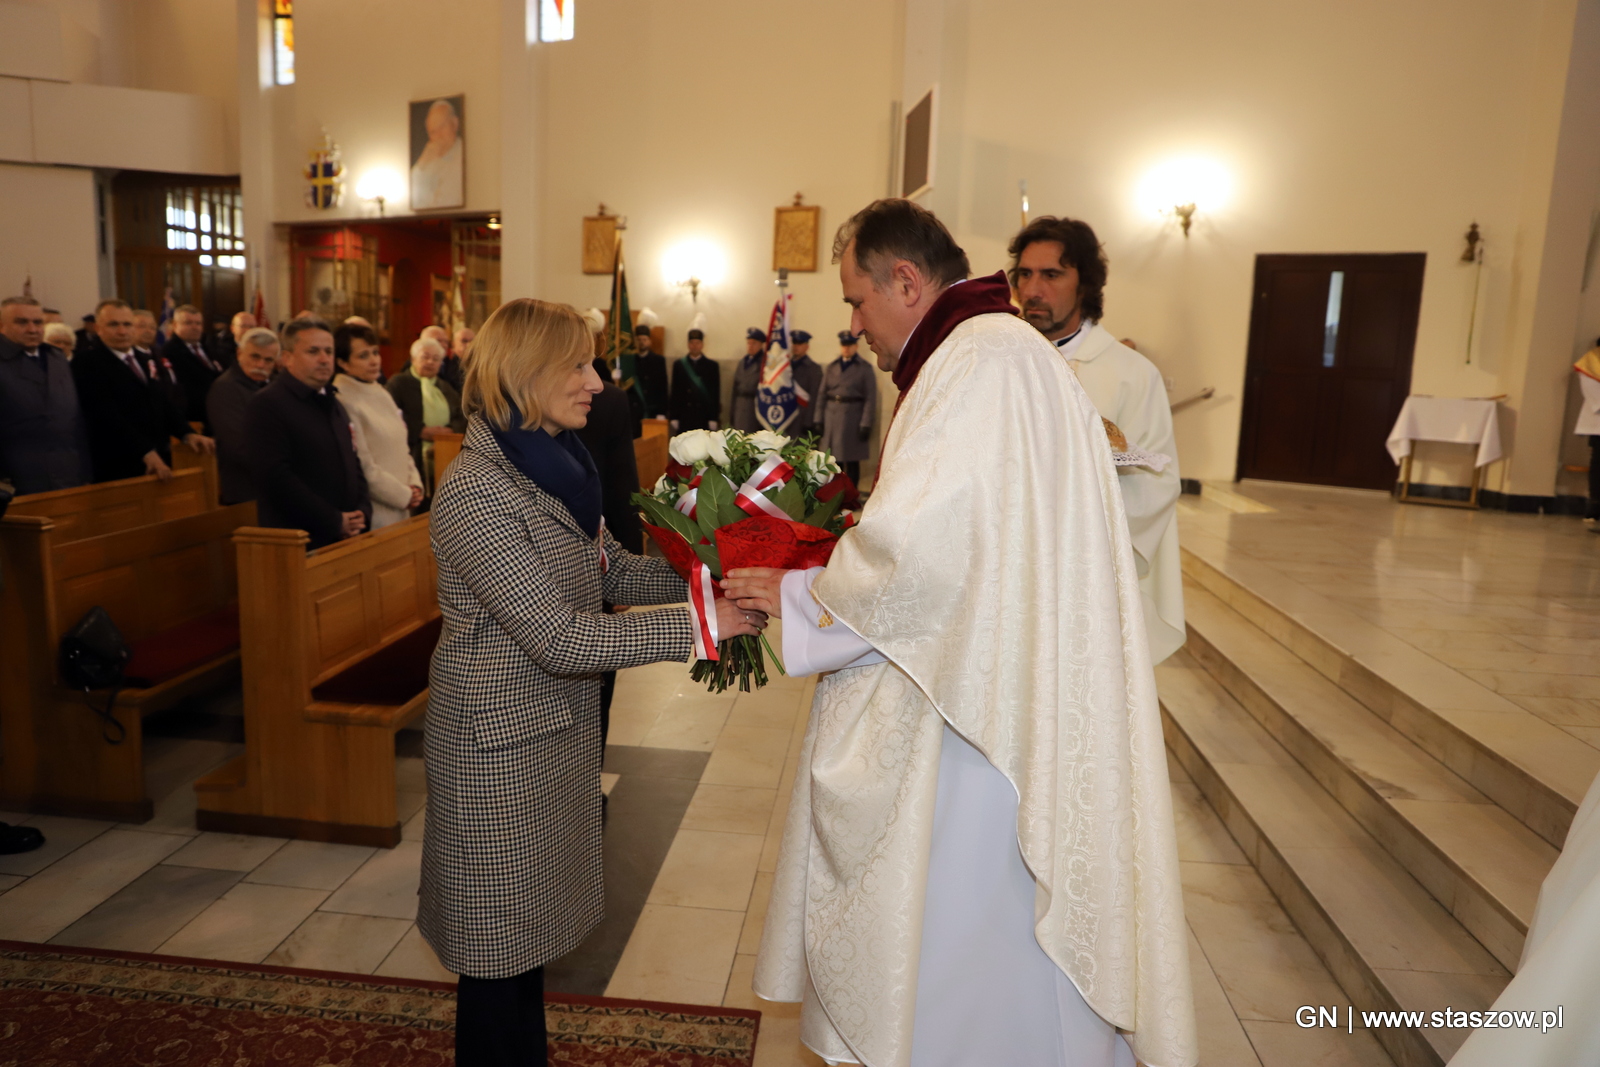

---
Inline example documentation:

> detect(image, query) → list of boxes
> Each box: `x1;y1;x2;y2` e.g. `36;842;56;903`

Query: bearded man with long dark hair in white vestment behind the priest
1010;216;1187;664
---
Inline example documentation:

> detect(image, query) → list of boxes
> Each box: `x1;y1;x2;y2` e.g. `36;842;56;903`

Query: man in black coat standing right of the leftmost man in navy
72;299;213;482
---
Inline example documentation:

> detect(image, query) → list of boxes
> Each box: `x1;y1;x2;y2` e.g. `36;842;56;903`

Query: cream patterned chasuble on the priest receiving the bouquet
754;314;1197;1067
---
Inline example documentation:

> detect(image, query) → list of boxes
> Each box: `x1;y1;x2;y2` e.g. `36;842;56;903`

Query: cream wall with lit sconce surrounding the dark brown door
906;0;1600;491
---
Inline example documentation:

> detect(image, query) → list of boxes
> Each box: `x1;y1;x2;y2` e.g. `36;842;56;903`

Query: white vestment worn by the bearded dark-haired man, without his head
1061;323;1187;664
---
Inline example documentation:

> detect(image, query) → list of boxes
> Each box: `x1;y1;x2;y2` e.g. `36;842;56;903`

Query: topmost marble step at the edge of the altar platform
1184;545;1600;848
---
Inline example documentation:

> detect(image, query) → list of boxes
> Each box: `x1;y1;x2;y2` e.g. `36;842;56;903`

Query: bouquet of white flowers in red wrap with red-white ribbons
634;430;853;693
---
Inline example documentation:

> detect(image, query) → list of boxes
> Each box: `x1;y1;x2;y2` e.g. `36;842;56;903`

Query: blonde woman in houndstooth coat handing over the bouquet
418;299;765;1067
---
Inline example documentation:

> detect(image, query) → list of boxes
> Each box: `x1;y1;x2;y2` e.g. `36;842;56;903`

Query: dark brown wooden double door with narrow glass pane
1238;253;1427;490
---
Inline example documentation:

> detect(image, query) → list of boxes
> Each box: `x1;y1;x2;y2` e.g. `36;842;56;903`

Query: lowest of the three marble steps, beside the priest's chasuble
1155;651;1510;1067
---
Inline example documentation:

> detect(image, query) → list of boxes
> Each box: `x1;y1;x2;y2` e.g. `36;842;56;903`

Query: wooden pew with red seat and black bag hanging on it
0;505;256;822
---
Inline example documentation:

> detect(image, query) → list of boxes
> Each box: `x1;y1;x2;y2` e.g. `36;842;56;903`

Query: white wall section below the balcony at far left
0;163;99;313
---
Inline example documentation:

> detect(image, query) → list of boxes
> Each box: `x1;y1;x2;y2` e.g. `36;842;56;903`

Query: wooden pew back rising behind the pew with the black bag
6;467;218;542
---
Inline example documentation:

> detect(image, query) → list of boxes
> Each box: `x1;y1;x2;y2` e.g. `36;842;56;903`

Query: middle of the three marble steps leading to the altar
1184;584;1557;968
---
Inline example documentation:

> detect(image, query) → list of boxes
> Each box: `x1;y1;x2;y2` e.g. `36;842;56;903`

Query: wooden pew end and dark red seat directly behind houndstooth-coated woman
195;515;442;848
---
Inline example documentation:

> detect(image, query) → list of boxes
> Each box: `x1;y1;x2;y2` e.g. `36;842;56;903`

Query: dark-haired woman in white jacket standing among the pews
333;325;422;530
